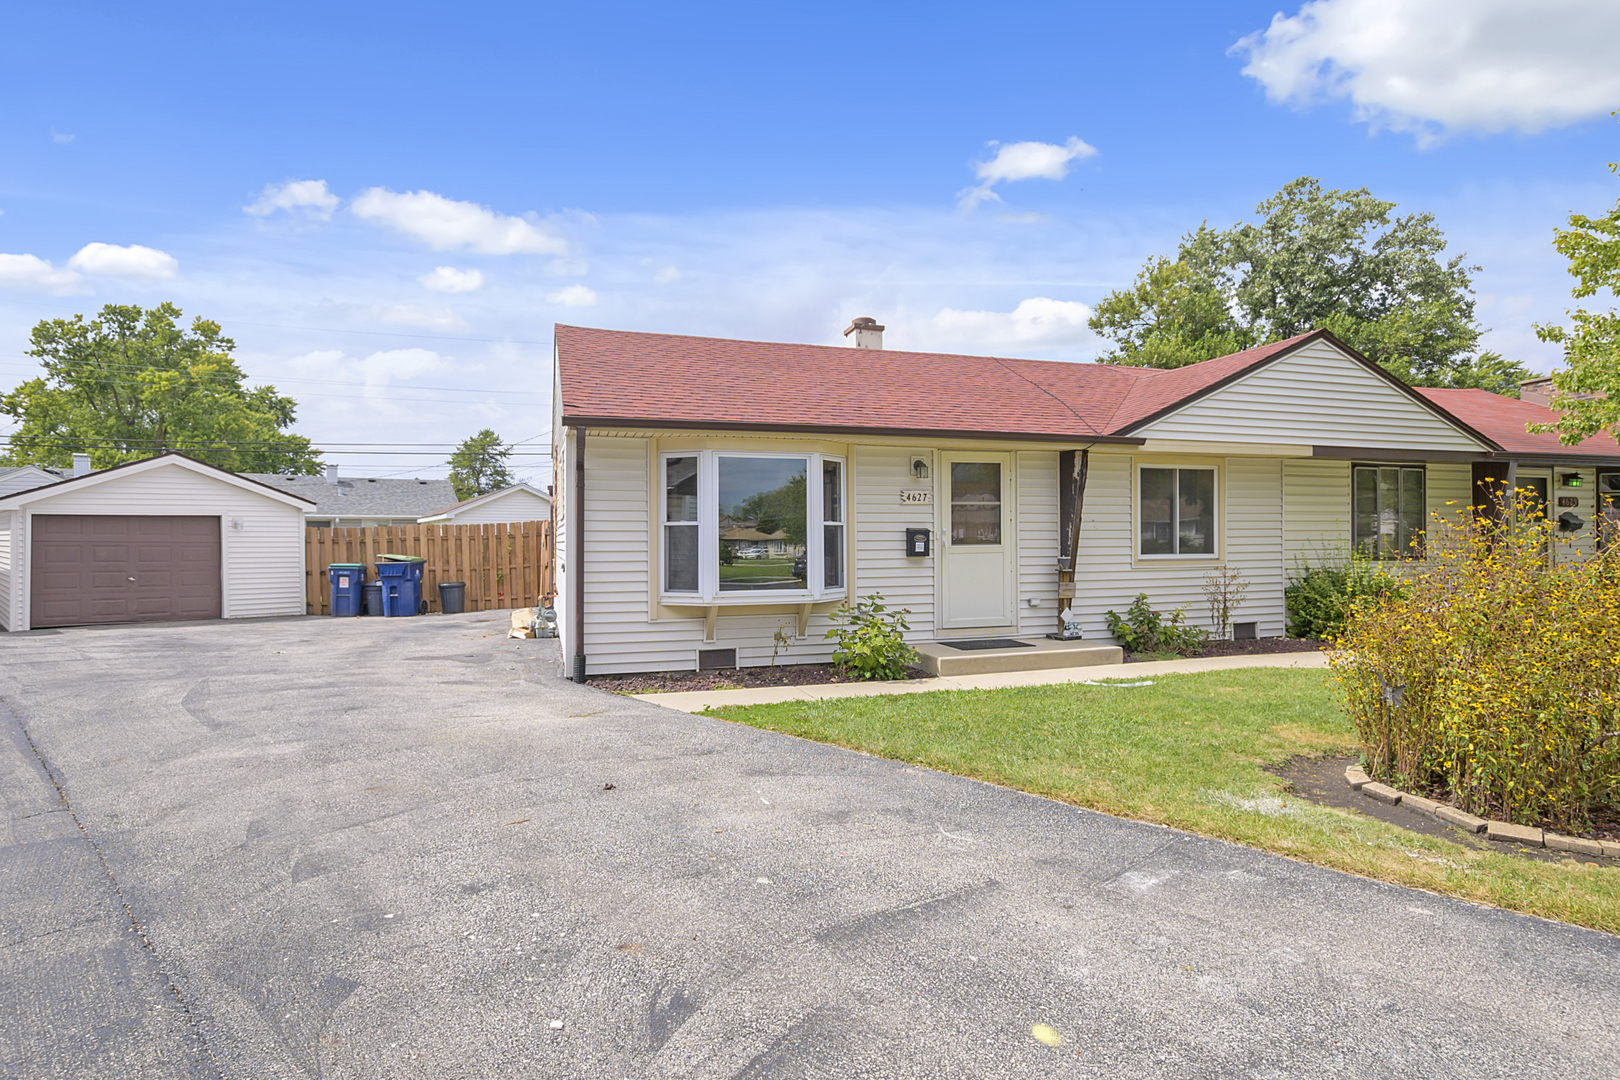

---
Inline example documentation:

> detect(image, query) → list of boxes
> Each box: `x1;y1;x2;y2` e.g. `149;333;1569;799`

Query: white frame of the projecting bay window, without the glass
656;450;851;606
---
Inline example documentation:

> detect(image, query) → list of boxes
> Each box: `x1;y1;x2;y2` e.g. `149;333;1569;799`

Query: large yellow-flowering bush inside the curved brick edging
1330;507;1620;829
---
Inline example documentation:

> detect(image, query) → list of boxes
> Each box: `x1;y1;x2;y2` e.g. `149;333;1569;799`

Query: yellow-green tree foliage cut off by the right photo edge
1536;110;1620;445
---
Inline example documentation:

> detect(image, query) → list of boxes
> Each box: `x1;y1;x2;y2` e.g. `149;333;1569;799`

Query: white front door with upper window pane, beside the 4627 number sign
940;453;1016;628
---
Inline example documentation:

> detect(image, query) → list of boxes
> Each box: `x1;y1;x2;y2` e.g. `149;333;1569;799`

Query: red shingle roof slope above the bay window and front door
557;325;1322;440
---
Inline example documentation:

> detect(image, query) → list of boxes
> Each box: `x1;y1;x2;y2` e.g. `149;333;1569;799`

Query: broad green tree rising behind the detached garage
0;303;321;473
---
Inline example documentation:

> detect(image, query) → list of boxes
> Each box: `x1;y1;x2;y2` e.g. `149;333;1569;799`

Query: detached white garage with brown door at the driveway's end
0;453;311;630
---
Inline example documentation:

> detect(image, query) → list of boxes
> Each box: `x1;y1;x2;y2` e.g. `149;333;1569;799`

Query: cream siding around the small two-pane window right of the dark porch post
1074;450;1283;641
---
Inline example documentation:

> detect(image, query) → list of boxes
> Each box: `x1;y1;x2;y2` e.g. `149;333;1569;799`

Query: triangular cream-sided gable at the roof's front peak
1131;342;1482;450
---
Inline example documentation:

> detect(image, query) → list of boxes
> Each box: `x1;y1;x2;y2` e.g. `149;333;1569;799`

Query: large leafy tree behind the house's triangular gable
1090;176;1529;395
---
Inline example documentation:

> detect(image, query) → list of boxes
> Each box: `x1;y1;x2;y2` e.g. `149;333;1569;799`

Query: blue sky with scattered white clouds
0;0;1620;478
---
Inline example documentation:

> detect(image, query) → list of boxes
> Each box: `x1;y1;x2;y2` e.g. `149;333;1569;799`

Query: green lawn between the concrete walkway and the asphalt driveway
713;667;1620;933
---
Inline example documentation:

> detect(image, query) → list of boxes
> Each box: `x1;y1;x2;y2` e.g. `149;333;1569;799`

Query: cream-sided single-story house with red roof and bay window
552;321;1620;678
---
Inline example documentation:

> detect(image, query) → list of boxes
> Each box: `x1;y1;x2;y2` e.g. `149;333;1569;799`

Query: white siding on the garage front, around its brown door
13;465;305;625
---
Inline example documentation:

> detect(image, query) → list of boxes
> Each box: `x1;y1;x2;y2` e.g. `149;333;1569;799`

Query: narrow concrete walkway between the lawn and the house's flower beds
635;653;1327;712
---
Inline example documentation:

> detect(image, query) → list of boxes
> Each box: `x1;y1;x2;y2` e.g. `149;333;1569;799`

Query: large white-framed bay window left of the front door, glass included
659;450;849;602
